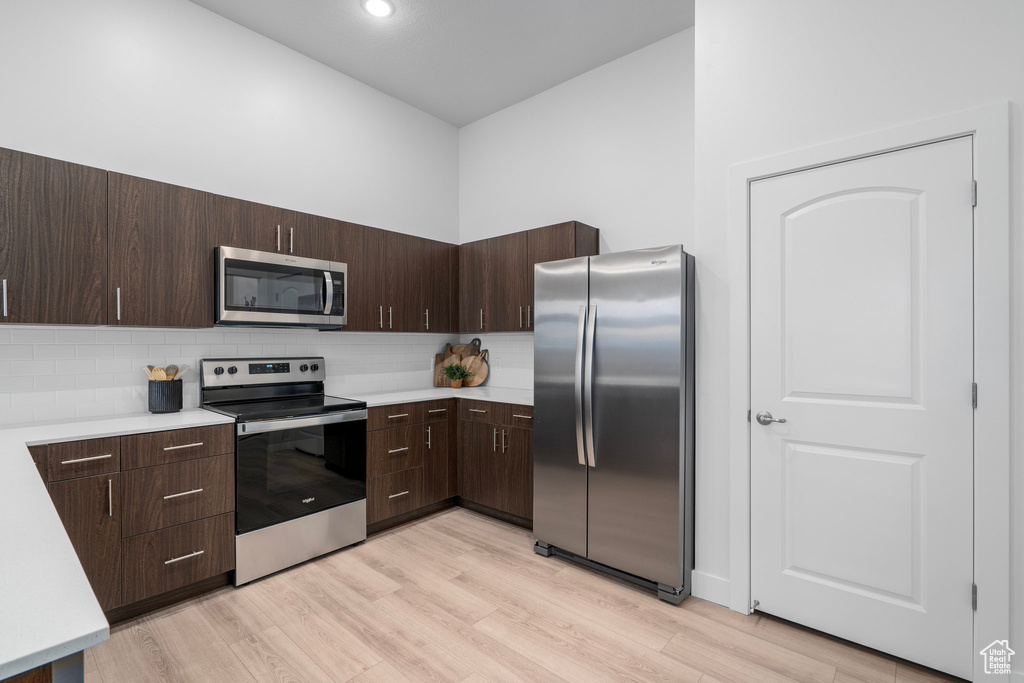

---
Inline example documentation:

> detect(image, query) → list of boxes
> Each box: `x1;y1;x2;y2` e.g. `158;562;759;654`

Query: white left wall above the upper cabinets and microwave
0;0;459;242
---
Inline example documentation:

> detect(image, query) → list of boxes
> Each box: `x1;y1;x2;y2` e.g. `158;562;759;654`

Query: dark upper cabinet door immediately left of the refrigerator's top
487;232;531;332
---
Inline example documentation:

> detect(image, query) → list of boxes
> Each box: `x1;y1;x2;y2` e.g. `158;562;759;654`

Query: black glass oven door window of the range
236;421;367;533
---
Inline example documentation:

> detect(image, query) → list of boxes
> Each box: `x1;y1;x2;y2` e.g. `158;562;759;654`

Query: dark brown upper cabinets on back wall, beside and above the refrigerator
459;221;599;333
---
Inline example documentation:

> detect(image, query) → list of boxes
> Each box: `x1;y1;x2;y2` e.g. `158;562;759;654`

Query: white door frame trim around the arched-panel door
727;101;1011;680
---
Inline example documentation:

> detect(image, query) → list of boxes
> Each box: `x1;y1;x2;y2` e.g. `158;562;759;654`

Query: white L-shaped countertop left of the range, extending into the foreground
0;410;232;679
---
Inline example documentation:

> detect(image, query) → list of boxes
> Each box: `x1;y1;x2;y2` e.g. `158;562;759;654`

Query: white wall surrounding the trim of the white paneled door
695;0;1024;667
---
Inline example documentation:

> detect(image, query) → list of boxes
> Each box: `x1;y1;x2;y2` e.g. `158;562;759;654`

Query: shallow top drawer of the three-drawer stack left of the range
121;425;234;470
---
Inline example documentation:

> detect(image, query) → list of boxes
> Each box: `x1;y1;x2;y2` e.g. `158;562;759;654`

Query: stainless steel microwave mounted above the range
216;247;348;329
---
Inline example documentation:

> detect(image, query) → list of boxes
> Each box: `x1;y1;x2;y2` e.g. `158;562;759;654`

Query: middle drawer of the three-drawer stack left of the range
121;455;234;538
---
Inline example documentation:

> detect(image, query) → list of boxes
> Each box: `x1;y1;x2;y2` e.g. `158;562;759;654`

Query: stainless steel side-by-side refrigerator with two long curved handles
534;246;693;604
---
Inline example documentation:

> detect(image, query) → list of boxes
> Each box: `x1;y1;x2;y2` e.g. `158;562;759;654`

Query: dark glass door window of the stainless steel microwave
223;258;327;315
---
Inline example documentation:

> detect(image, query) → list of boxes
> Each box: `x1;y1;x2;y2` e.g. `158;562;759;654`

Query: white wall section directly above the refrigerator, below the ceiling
459;29;693;252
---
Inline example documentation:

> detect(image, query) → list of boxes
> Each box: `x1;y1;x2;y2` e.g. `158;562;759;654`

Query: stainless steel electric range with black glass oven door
200;357;367;586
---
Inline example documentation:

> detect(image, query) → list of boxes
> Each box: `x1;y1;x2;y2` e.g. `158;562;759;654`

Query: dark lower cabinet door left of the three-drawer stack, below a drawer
49;474;121;609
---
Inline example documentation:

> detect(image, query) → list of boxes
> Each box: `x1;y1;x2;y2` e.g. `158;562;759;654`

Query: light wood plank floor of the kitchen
85;508;953;683
